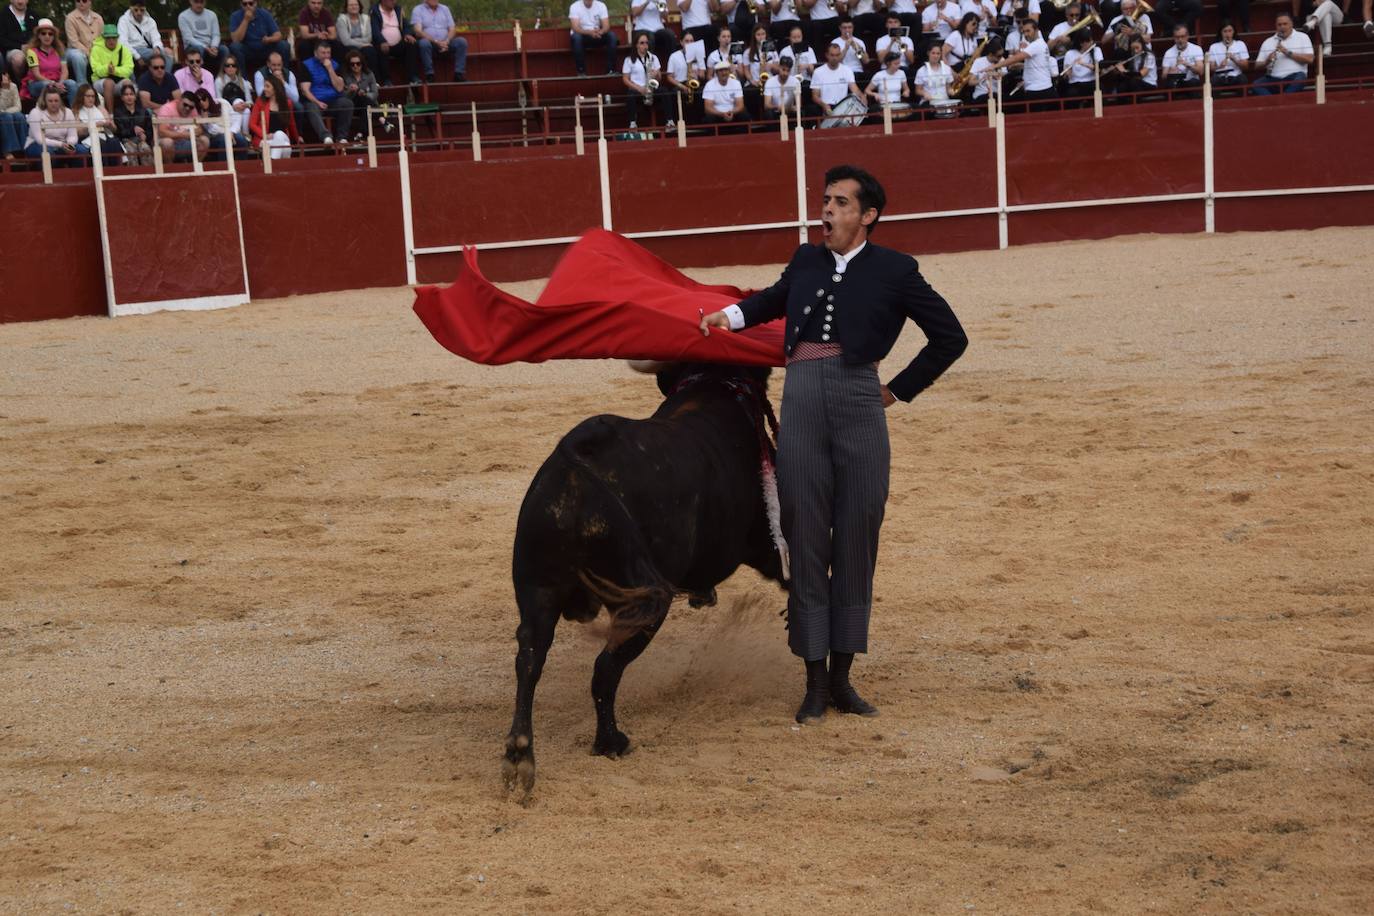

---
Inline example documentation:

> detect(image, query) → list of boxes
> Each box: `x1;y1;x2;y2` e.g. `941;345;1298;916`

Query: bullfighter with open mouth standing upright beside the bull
701;165;969;722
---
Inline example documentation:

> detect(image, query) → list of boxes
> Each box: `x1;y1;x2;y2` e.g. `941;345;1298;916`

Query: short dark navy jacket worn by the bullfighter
739;242;969;401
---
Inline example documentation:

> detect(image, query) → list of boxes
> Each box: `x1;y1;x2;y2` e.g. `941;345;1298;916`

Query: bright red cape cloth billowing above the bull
415;229;783;365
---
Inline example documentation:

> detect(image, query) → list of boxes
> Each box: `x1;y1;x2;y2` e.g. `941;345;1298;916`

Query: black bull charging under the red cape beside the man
502;364;783;794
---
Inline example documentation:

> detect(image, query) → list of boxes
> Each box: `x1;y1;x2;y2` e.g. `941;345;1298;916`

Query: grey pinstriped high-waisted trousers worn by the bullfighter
778;356;890;661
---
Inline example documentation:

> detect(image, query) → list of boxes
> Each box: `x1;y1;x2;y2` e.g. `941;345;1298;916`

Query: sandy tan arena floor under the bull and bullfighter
0;229;1374;913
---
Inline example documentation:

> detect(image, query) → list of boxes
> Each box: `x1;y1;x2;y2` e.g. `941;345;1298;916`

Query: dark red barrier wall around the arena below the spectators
0;92;1374;321
